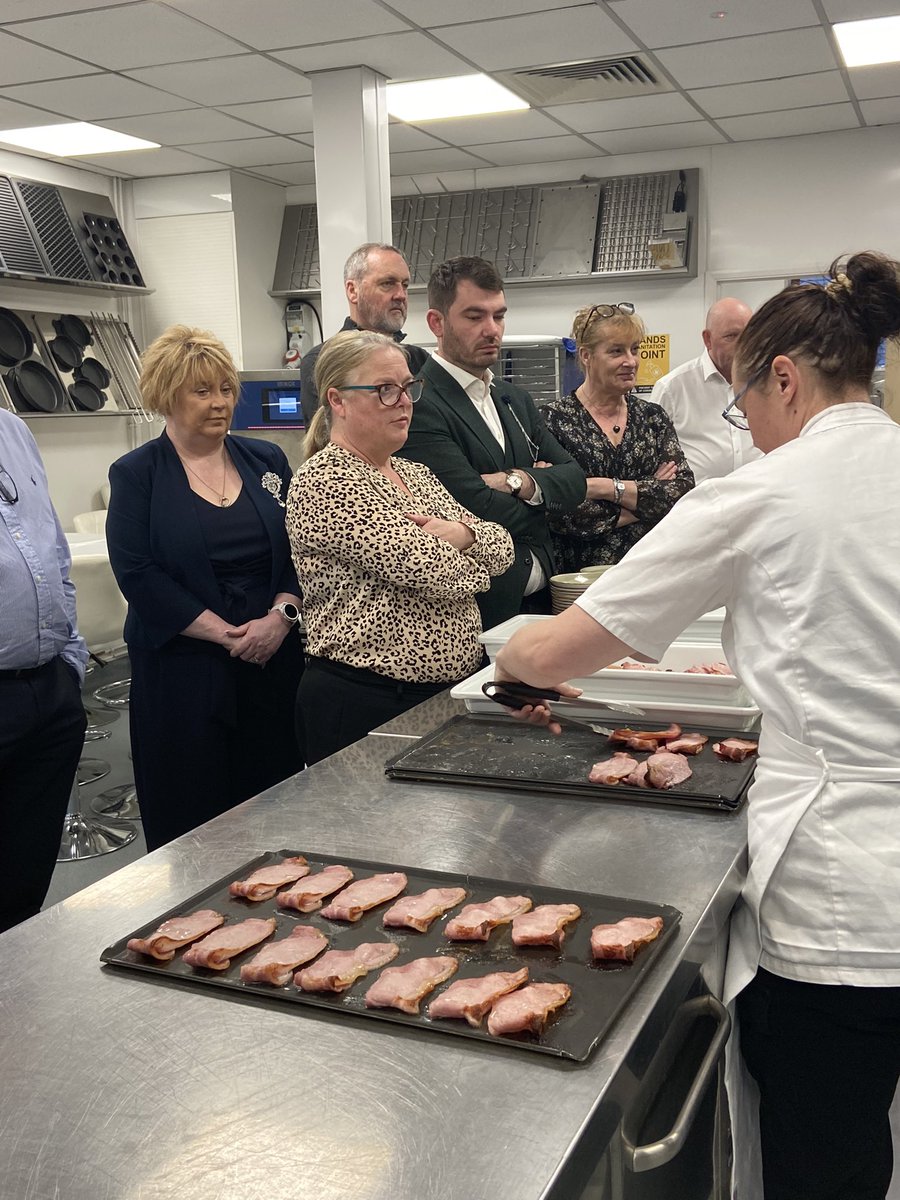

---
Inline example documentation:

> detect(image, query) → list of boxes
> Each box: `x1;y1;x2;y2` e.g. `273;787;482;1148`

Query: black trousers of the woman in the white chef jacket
738;971;900;1200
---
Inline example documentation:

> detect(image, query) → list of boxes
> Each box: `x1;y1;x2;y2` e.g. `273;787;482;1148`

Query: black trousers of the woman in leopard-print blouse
296;658;452;766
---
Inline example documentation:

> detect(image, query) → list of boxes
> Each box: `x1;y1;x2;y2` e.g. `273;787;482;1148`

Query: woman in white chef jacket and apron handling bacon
497;252;900;1200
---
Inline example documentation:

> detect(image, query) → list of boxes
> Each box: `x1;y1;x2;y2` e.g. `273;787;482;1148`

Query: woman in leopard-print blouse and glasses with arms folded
287;331;512;763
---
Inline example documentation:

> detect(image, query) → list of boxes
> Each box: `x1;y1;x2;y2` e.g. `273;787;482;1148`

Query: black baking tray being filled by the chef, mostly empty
384;713;756;812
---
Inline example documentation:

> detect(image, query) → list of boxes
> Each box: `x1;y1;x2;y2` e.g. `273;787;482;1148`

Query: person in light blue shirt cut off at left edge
0;408;88;931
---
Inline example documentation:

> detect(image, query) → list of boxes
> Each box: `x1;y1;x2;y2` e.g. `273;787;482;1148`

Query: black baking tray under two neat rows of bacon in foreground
101;850;682;1062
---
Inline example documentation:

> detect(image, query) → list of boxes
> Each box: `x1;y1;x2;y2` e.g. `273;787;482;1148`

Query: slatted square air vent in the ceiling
496;54;672;106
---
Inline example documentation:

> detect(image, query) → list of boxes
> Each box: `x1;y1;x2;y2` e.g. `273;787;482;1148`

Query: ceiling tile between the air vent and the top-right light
658;29;838;88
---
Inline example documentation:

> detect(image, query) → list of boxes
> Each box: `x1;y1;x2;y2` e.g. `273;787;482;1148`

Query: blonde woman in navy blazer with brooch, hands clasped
107;325;302;850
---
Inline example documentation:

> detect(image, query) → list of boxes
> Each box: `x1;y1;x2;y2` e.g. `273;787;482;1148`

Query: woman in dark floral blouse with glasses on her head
541;302;694;571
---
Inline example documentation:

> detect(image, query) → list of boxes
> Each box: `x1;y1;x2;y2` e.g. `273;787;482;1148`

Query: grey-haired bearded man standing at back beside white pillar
300;241;428;426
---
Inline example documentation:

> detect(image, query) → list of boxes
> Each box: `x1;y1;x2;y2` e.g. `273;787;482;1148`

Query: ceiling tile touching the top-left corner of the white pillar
127;55;308;107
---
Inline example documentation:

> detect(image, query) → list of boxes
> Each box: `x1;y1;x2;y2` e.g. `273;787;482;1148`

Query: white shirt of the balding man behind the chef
650;350;760;484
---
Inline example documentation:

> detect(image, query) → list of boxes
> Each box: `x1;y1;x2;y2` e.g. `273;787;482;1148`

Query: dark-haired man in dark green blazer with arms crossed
400;257;587;629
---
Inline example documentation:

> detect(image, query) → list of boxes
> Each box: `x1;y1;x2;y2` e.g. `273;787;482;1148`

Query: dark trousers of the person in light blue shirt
0;658;88;931
